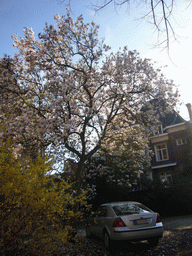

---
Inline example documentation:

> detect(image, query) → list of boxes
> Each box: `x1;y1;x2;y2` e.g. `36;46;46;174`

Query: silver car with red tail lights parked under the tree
86;202;163;249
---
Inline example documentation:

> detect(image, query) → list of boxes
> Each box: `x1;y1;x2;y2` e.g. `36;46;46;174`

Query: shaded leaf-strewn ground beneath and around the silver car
72;215;192;256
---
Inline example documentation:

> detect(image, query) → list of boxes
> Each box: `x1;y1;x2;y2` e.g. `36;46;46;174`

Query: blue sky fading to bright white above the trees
0;0;192;120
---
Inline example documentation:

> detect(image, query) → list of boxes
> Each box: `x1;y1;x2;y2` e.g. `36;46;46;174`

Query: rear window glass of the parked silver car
113;203;152;216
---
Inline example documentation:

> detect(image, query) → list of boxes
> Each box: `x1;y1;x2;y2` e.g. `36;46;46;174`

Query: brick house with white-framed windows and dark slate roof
150;104;192;184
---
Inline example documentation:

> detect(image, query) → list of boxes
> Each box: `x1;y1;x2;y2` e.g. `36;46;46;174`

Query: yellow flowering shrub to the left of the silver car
0;145;86;255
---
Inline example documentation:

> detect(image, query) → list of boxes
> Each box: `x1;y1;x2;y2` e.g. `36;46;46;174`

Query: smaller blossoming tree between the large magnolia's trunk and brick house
85;116;152;197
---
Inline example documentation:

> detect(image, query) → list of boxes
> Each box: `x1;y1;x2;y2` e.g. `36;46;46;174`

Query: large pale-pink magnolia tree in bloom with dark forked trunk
1;13;177;192
